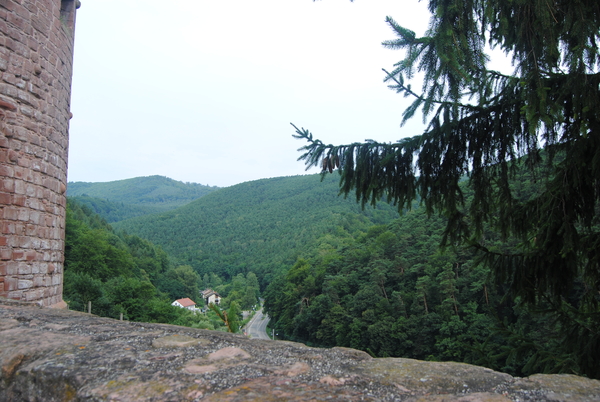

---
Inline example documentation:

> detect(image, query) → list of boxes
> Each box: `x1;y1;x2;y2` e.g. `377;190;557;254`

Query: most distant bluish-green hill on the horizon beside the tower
67;176;219;222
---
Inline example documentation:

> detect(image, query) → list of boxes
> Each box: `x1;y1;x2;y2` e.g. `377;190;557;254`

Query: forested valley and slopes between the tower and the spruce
65;175;595;376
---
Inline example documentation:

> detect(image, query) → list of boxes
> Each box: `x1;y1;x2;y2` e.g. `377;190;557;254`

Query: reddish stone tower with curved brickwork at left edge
0;0;79;306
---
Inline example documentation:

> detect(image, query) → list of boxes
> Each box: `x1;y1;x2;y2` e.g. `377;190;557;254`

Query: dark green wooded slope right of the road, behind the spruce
265;176;600;378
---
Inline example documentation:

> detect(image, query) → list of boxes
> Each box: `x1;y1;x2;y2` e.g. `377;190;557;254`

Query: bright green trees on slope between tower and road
63;199;260;330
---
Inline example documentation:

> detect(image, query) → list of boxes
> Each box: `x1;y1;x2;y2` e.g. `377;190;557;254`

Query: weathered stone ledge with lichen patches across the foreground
0;299;600;402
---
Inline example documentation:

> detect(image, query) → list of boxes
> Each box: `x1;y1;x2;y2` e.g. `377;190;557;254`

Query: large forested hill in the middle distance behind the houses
114;175;398;285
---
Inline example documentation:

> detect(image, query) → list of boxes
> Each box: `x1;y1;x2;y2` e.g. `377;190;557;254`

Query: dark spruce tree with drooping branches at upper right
294;0;600;312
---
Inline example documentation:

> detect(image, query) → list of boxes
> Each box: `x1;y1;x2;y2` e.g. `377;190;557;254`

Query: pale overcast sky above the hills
68;0;429;187
